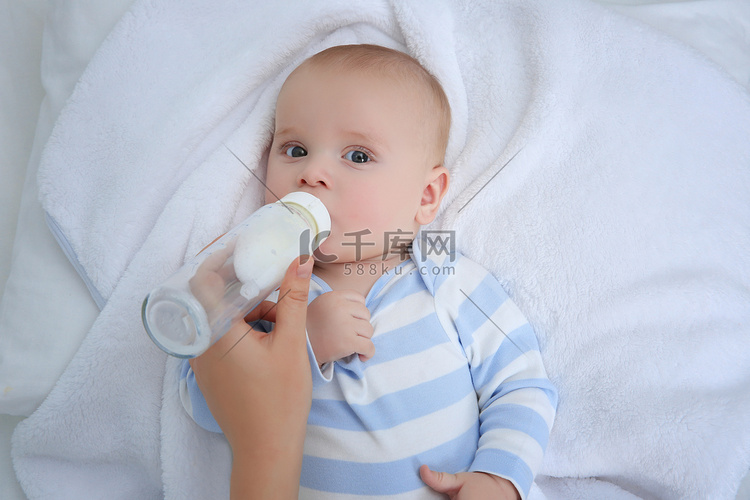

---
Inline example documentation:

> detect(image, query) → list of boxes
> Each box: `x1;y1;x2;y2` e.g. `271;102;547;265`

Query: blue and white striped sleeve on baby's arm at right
436;257;557;498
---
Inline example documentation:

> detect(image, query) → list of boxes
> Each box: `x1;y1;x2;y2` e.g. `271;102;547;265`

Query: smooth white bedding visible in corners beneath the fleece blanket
0;0;750;499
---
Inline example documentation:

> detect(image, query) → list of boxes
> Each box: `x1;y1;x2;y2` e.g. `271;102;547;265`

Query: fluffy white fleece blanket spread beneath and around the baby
13;0;750;499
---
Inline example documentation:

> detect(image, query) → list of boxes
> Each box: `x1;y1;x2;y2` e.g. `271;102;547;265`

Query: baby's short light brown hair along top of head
302;44;451;164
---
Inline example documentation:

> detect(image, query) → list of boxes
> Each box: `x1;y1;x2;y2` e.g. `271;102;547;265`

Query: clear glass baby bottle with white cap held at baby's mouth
141;191;331;358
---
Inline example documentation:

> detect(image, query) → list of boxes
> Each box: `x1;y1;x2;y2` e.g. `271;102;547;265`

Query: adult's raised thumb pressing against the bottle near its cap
274;255;313;346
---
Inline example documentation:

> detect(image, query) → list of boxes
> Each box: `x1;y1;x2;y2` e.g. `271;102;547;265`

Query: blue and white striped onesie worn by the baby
180;238;557;500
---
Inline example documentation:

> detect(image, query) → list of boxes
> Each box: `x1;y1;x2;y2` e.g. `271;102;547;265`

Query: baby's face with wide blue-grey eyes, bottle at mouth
266;65;434;262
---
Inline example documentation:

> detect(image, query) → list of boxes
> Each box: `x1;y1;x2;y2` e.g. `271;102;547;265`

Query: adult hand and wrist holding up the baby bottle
190;257;313;499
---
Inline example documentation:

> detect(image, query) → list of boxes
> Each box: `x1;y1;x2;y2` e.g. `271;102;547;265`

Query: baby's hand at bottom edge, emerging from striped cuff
419;465;521;500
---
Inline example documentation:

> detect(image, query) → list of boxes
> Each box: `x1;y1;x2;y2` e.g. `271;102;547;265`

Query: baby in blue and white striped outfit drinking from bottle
180;45;557;499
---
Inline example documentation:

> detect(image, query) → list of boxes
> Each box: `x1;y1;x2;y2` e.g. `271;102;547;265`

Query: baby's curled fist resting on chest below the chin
307;290;375;365
